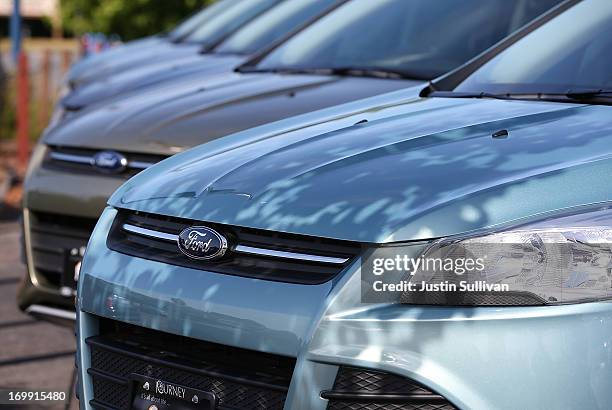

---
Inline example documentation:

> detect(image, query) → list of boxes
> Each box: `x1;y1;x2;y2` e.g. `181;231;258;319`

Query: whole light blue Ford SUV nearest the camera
77;0;612;410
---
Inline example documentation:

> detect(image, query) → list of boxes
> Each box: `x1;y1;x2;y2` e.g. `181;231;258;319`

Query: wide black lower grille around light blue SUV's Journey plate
87;319;295;410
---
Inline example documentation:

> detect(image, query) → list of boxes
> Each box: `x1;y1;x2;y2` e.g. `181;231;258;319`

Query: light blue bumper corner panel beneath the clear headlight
304;262;612;410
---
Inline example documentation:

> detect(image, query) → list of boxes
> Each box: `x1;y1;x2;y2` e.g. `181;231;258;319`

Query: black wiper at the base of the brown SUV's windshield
237;67;430;81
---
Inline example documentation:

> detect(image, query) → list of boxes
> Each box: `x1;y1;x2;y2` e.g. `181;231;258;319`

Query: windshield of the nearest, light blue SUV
455;0;612;94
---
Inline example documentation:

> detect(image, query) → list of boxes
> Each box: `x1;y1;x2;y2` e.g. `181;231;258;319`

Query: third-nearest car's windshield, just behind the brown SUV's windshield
215;0;338;54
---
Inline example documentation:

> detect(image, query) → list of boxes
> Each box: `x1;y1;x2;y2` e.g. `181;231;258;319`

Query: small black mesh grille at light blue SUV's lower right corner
321;367;455;410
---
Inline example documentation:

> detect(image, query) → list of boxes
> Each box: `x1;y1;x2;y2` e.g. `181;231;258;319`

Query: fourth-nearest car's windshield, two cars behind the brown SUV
185;0;279;47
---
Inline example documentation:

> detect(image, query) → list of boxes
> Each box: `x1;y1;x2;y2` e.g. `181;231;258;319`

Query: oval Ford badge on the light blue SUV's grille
177;226;227;259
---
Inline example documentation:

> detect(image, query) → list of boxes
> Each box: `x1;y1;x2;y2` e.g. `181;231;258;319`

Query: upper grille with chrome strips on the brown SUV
43;146;167;178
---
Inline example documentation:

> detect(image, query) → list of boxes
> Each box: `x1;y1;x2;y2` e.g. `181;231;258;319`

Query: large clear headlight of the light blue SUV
364;209;612;306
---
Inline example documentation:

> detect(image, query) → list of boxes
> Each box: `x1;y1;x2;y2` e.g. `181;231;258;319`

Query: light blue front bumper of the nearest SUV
77;209;612;409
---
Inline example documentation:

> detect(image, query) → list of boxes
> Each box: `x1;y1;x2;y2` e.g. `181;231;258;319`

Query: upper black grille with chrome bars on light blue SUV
107;210;361;284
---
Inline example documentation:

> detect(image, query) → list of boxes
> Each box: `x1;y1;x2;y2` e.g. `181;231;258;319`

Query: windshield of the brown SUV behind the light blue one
257;0;560;79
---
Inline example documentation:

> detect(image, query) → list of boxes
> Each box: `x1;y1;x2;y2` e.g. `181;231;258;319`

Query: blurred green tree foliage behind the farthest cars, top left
61;0;214;41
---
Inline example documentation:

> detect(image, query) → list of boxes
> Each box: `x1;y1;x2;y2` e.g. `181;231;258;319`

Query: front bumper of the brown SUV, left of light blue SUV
17;157;130;323
